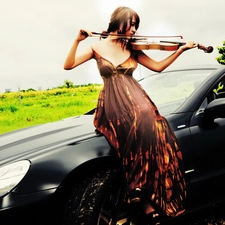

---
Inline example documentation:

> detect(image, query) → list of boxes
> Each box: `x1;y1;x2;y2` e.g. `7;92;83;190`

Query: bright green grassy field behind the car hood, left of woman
0;85;102;134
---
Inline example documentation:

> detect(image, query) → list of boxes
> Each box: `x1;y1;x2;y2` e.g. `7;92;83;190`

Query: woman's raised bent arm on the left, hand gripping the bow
64;30;93;70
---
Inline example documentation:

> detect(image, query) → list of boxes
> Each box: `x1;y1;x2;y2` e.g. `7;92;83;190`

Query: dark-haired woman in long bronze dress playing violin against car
64;7;197;223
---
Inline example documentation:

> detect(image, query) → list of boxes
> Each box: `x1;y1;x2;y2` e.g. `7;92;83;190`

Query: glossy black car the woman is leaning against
0;65;225;225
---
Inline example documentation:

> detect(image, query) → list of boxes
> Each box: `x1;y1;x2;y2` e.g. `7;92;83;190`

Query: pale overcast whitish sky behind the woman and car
0;0;225;93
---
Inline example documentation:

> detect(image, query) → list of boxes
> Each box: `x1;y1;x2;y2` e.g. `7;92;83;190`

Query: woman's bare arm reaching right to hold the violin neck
136;41;198;72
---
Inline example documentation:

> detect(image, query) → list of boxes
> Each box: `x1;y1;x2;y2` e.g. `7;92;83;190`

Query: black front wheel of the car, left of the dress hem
64;170;129;225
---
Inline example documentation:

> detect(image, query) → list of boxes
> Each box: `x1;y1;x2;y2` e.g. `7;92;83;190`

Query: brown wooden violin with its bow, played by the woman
87;32;213;53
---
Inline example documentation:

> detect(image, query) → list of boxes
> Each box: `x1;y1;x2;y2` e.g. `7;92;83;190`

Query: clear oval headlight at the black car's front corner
0;160;30;197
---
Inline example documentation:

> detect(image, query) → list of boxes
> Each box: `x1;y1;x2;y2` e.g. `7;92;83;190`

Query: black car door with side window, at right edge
190;77;225;202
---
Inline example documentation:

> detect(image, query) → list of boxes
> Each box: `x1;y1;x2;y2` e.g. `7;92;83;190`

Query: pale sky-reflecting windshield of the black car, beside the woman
140;69;213;116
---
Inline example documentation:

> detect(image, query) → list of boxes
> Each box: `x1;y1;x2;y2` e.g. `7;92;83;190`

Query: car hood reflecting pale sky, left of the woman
0;115;96;165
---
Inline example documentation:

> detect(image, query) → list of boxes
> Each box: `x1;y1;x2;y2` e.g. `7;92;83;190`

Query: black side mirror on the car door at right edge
203;98;225;122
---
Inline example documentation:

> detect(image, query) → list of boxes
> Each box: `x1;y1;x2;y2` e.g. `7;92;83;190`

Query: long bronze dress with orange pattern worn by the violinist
93;50;186;216
